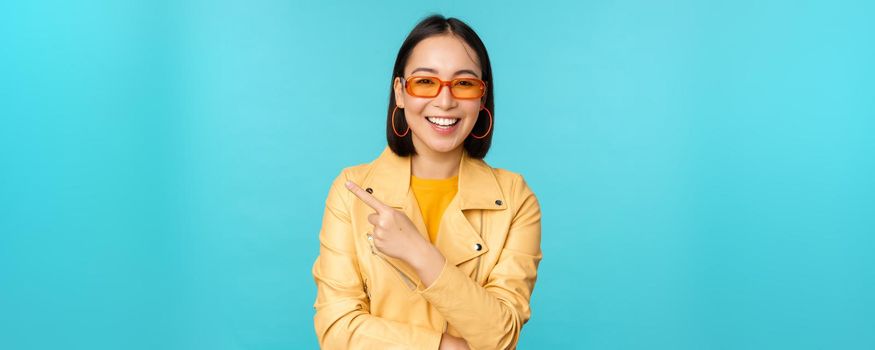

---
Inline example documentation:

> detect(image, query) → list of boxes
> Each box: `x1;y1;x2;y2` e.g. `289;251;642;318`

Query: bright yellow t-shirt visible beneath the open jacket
410;175;459;243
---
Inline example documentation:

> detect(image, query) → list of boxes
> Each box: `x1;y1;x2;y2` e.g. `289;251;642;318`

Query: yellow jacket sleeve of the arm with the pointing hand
418;176;542;349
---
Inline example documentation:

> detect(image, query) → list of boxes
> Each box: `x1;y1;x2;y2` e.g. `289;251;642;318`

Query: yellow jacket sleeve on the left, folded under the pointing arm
313;172;442;349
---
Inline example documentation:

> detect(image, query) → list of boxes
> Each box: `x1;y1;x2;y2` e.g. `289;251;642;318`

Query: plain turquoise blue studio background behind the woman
0;0;875;349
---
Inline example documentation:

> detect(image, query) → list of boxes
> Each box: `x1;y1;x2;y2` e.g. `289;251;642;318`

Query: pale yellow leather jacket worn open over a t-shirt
313;147;542;349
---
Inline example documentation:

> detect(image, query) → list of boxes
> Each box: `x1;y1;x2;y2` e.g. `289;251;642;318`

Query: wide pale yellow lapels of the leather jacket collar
364;146;507;210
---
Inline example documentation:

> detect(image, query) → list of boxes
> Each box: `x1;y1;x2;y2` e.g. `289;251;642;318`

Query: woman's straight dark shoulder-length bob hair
386;15;495;159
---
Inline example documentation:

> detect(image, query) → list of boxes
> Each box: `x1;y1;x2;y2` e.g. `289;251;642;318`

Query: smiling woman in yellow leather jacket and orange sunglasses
313;15;541;349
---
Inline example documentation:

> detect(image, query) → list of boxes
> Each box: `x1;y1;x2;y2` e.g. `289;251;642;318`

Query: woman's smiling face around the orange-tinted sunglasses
394;34;489;153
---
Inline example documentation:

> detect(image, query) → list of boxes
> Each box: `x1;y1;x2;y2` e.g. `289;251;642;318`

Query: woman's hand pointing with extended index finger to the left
346;181;431;264
